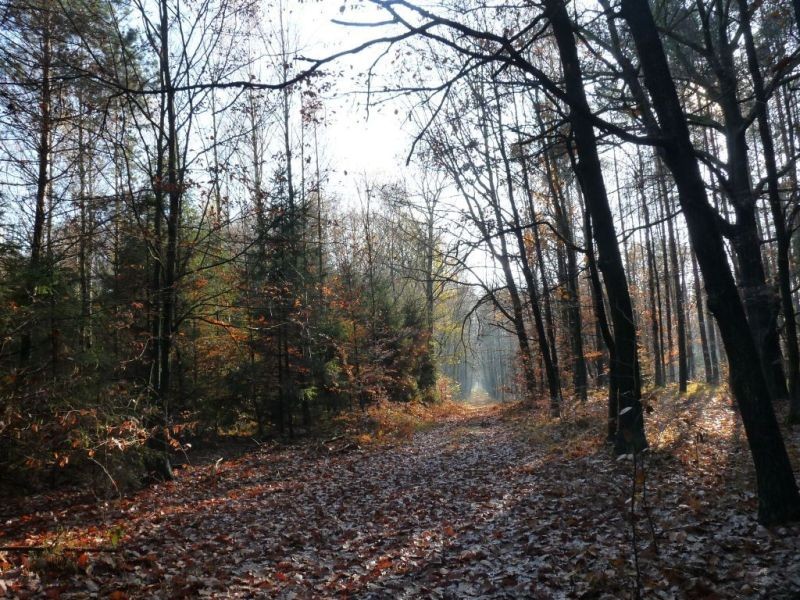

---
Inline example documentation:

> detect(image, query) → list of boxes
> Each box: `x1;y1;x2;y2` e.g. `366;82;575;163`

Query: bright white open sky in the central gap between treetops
278;0;520;281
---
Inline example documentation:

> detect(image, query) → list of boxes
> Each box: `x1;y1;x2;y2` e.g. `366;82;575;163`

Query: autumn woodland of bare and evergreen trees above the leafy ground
0;0;800;596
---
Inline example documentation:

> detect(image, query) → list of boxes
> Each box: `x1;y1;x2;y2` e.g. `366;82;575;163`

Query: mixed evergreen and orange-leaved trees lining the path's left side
0;0;468;488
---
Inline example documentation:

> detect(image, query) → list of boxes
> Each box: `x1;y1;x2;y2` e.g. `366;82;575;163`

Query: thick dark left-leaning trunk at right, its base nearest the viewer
621;0;800;524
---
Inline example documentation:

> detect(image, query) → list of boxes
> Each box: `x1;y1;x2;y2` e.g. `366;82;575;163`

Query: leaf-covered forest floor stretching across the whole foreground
0;389;800;600
